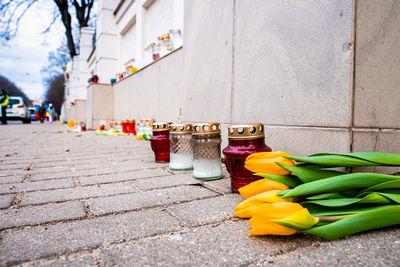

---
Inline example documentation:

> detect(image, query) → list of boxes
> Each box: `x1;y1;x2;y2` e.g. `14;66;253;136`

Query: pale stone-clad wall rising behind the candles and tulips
89;0;400;172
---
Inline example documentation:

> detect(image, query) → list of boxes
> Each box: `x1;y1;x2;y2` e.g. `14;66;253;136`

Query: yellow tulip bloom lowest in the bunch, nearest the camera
249;202;318;235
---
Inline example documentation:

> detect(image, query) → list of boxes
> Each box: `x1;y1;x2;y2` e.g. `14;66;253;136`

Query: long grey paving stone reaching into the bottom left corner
0;209;182;265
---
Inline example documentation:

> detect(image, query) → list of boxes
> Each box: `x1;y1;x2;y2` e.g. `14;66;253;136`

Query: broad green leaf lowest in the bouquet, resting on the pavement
303;205;400;240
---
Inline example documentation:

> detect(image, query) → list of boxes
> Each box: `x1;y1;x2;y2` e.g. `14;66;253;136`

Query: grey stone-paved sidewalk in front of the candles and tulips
0;124;400;266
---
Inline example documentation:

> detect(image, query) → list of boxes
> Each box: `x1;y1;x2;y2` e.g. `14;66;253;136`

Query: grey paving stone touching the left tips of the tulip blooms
167;194;243;227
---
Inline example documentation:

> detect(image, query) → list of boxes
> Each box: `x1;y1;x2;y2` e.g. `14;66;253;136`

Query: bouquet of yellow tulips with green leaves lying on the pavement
235;151;400;240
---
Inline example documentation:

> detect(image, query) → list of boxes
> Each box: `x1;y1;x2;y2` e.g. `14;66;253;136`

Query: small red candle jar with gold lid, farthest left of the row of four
150;122;170;162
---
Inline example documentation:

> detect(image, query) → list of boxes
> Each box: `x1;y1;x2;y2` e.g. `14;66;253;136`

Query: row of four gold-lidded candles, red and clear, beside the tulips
150;122;271;192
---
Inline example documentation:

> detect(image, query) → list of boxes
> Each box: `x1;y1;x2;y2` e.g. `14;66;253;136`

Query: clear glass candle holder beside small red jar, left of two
169;123;193;171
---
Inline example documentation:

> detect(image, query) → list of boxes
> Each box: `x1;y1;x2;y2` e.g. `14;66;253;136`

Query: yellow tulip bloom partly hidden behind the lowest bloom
235;190;290;218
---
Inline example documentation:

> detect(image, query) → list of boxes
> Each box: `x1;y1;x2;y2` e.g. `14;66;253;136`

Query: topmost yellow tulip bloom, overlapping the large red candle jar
244;151;296;175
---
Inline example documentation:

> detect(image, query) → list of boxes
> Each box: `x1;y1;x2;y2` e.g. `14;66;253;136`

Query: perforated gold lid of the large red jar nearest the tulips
228;123;265;139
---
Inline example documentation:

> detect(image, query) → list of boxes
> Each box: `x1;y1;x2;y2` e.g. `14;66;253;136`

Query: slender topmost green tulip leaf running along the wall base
284;153;379;168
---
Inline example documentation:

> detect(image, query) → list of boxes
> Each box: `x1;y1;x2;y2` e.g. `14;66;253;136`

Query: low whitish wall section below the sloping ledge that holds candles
113;49;183;121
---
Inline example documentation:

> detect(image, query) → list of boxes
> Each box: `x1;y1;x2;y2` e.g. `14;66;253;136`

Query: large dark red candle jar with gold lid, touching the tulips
222;123;272;193
